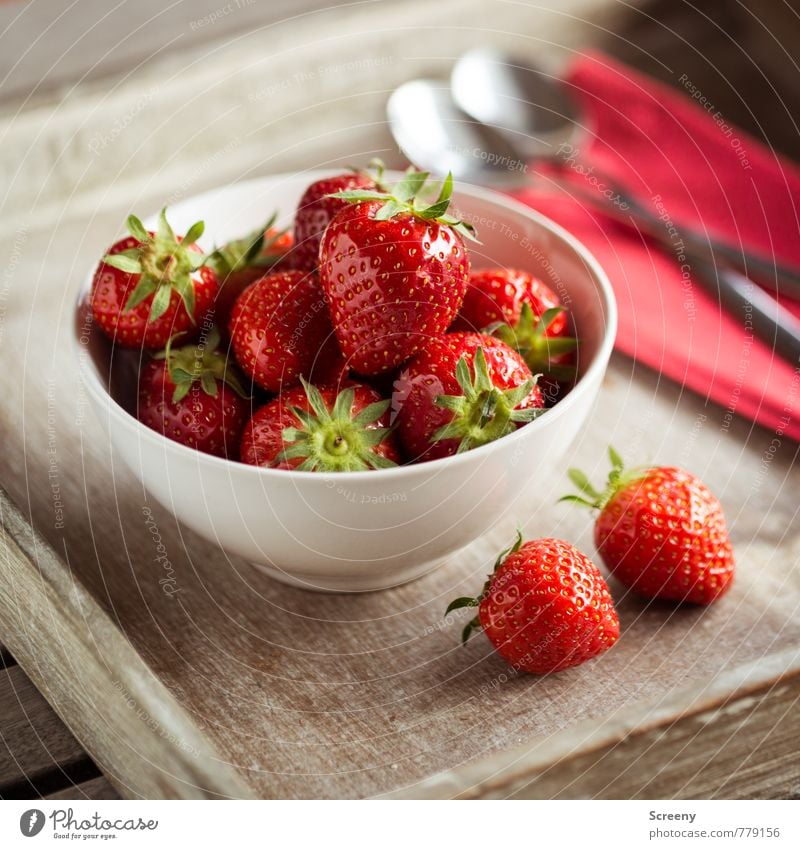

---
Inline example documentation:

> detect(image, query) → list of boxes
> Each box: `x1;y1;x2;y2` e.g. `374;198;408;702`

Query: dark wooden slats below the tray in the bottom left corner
0;666;93;798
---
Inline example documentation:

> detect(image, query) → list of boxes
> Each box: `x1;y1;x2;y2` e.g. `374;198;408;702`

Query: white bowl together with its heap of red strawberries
76;163;616;592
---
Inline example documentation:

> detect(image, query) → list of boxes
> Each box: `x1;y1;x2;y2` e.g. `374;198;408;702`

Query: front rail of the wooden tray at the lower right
394;650;800;799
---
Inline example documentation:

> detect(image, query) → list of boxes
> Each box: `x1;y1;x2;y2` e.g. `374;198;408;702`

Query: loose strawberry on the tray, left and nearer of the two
445;534;619;675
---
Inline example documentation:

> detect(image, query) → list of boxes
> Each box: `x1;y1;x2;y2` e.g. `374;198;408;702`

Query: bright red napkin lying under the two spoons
520;53;800;440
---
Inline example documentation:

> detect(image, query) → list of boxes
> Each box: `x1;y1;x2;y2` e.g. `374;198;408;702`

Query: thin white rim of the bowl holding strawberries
72;169;618;485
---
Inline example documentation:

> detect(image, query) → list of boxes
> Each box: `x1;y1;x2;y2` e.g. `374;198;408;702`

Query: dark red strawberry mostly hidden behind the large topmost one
293;168;382;271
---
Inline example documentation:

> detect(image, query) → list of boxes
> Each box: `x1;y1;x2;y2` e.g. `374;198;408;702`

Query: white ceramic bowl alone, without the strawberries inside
76;172;616;591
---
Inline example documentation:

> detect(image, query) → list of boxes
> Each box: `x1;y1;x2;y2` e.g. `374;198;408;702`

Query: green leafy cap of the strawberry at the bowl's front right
432;348;545;454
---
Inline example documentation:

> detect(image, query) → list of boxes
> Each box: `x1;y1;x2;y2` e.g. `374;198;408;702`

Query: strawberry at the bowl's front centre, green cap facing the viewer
241;381;400;472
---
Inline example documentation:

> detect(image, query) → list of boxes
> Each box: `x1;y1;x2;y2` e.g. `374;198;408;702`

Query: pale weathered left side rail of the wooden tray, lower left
0;492;249;798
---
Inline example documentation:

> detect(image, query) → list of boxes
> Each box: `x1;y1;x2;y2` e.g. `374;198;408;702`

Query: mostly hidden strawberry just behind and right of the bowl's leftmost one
208;215;294;333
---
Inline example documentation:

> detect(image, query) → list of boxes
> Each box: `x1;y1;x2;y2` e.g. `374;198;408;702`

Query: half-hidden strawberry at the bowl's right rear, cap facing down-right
452;268;578;380
